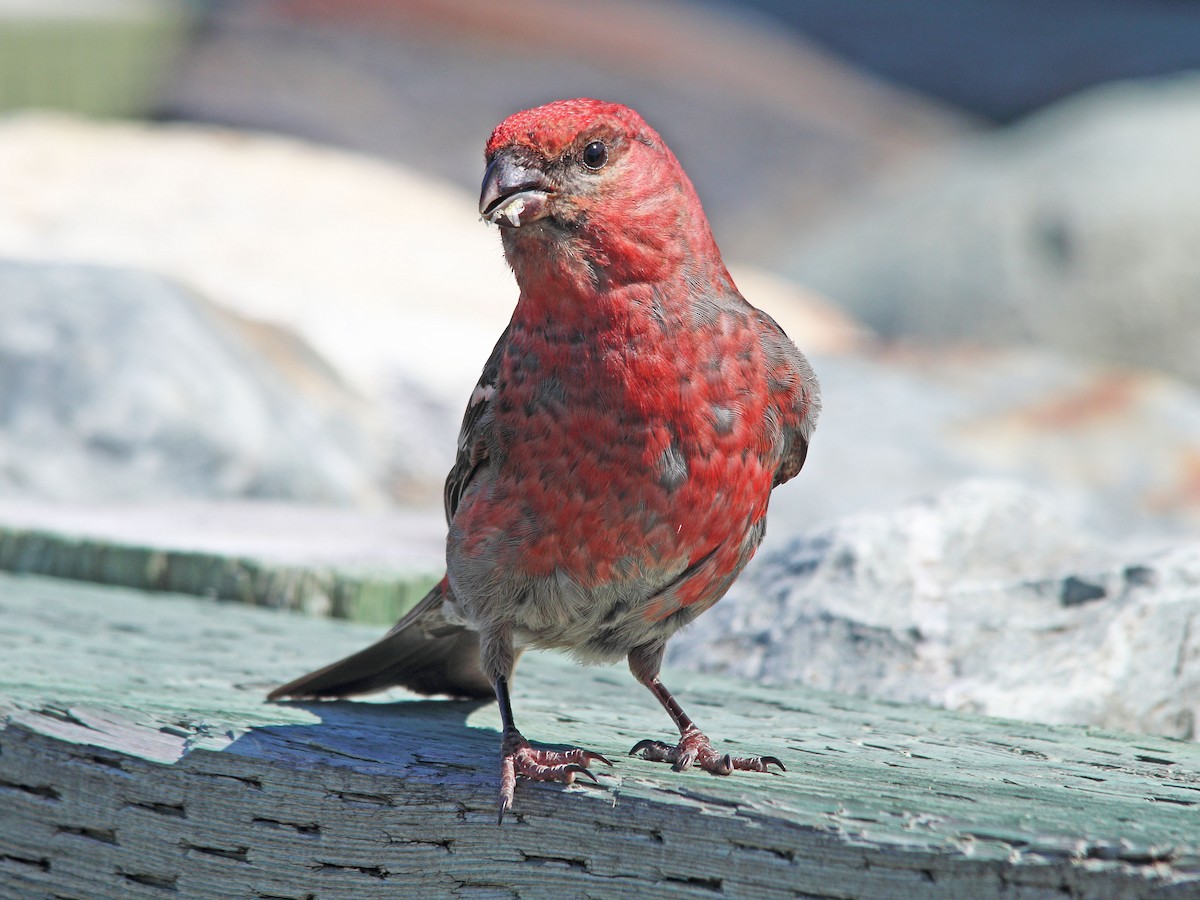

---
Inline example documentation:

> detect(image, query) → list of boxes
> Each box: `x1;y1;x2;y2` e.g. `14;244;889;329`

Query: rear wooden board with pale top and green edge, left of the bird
0;499;445;624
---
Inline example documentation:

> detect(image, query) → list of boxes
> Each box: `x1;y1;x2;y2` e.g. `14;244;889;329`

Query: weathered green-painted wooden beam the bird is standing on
0;575;1200;899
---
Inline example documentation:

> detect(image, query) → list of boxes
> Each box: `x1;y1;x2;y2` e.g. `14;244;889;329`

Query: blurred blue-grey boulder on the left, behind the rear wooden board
0;260;378;503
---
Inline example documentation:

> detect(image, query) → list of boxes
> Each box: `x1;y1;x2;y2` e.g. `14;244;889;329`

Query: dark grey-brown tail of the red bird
266;578;493;700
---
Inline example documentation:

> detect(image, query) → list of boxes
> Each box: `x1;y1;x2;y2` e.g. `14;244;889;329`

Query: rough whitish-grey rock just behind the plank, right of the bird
670;481;1200;738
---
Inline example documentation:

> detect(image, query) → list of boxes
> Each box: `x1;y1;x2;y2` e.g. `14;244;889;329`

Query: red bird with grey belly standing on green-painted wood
270;100;820;820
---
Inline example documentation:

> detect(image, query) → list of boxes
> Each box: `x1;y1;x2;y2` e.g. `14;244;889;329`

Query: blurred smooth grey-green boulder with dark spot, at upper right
781;76;1200;382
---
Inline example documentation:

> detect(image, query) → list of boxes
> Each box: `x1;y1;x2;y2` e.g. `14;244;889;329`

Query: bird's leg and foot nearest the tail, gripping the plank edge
482;635;612;823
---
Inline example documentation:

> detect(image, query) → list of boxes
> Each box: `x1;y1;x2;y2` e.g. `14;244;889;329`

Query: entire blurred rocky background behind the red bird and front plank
0;0;1200;737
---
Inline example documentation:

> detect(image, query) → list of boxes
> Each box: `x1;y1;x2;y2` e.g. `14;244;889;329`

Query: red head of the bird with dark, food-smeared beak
479;100;727;300
